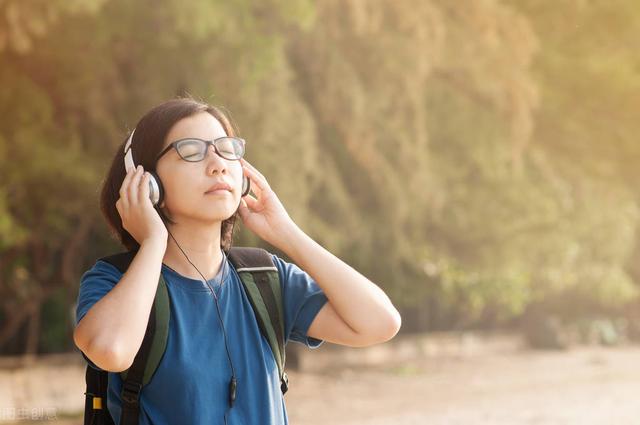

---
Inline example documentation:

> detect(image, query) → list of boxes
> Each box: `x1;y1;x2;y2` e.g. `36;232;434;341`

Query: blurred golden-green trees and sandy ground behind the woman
0;0;640;424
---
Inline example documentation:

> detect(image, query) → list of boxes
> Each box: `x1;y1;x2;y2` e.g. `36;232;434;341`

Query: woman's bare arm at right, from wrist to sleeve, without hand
276;225;402;347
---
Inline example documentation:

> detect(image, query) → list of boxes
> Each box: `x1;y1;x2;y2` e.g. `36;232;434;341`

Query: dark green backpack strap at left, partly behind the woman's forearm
101;251;170;425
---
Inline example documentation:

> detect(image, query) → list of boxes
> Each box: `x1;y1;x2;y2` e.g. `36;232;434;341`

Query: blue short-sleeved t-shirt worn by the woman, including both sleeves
76;254;327;425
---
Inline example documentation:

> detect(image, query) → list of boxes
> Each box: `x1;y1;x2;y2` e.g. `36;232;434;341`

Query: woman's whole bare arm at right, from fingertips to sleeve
239;158;401;347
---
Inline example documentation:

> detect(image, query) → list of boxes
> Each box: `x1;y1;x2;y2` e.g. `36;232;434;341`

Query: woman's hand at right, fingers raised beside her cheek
239;158;296;248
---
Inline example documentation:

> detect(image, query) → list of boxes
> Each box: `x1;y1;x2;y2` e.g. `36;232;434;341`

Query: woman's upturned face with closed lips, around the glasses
156;112;242;222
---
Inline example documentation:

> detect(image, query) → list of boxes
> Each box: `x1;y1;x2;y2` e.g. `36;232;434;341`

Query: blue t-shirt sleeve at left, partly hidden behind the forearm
75;260;122;370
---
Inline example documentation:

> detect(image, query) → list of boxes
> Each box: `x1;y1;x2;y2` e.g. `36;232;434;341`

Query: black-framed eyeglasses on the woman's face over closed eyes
156;136;245;162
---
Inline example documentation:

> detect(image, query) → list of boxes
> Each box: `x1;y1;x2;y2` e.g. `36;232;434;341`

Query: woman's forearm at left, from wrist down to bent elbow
74;241;166;370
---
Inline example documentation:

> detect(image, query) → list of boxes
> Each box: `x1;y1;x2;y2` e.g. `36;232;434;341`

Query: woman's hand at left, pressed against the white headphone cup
116;165;168;245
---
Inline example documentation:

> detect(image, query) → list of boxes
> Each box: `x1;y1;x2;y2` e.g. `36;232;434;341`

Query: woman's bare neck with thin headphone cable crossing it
162;222;223;280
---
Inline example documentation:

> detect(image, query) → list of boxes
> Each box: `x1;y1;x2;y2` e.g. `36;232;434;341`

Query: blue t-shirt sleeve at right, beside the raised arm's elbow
272;254;328;348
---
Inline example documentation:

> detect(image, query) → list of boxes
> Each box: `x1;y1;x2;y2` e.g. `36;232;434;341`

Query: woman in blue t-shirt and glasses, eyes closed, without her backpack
74;98;400;424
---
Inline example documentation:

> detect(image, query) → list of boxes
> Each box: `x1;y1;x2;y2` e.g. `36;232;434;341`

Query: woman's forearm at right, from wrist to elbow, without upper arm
278;225;401;335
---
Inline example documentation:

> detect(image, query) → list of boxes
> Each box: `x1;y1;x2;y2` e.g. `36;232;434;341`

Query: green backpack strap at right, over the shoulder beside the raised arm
228;247;289;394
